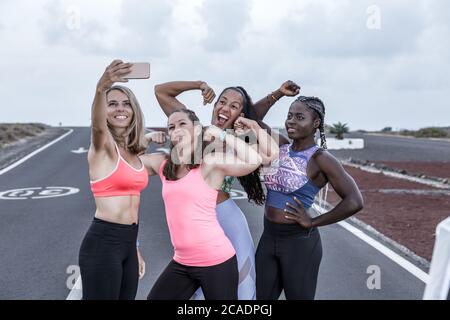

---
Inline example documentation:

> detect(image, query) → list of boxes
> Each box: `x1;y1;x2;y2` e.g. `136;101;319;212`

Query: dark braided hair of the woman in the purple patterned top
293;96;328;214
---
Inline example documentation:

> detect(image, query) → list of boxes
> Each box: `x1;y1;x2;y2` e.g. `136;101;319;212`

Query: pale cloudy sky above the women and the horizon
0;0;450;130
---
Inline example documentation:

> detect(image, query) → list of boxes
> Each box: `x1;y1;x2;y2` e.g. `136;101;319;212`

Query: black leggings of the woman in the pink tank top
147;256;239;300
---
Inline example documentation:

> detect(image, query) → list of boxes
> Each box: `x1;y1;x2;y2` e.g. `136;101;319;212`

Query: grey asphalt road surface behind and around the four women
0;128;425;299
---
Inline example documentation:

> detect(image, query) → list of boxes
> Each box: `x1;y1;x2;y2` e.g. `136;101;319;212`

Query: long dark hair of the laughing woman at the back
214;86;266;205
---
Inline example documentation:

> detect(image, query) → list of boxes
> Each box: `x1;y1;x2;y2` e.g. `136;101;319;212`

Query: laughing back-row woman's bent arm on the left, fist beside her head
155;81;216;116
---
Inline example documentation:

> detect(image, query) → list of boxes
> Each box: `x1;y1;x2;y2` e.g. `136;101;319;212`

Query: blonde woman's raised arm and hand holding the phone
91;60;132;151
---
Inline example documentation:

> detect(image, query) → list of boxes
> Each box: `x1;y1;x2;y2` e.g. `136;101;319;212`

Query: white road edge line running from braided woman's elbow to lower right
314;205;428;283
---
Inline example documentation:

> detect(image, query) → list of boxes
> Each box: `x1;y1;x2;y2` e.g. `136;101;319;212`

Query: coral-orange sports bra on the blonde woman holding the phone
91;142;148;197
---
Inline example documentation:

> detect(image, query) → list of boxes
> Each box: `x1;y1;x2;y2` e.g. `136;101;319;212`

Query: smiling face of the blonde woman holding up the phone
106;90;134;129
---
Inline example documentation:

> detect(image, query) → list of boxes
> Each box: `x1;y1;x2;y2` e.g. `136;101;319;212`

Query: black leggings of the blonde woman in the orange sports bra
79;218;139;300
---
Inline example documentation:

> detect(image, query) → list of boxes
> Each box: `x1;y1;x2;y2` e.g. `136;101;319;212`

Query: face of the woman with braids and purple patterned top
285;102;321;140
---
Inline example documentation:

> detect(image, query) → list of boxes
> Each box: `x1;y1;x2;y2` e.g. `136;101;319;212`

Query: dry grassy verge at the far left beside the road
0;123;49;148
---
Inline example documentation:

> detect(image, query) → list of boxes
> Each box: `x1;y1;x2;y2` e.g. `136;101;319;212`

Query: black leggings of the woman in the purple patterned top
256;218;322;300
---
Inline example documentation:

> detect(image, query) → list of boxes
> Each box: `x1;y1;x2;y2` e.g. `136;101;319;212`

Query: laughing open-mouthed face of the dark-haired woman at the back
211;89;244;129
